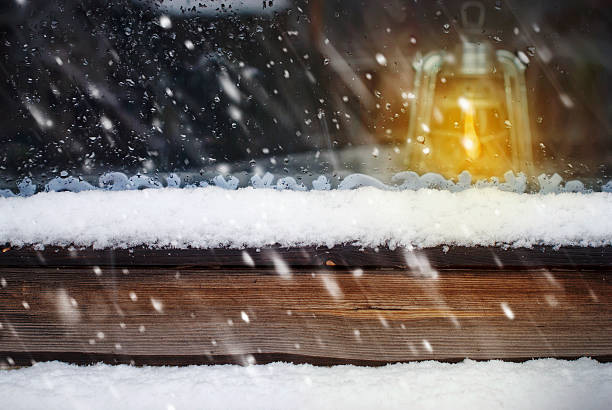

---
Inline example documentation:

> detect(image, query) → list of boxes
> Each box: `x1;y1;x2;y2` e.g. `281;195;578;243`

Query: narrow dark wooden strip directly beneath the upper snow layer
0;245;612;269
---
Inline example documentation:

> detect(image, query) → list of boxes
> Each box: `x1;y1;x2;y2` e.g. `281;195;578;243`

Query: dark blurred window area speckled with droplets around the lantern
0;0;612;186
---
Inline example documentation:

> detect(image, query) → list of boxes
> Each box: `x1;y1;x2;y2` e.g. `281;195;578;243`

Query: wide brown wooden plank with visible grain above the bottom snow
0;267;612;364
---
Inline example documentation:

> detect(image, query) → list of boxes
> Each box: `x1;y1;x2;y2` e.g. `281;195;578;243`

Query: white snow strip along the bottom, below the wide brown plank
0;358;612;410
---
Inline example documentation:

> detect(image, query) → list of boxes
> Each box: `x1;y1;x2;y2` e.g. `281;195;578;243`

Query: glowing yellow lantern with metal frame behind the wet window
407;2;533;178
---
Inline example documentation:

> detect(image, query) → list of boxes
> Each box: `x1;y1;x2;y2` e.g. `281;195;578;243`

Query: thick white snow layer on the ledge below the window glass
0;187;612;248
